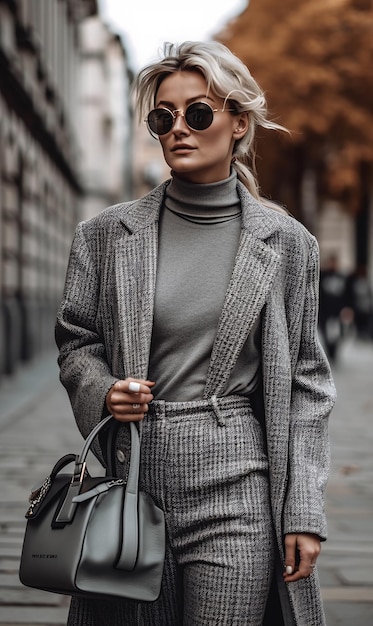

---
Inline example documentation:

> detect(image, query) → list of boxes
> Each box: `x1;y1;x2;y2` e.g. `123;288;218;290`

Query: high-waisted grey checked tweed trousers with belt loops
68;396;274;626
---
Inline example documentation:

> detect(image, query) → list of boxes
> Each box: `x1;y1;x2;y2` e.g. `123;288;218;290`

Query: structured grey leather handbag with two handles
19;416;165;601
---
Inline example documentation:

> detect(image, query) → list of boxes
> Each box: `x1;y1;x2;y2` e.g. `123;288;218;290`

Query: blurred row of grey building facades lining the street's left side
0;0;132;382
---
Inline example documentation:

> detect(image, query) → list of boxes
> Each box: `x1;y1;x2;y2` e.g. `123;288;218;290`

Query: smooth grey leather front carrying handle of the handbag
56;415;140;571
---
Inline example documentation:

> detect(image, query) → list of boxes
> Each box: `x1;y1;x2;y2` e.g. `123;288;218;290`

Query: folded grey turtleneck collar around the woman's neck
165;170;241;224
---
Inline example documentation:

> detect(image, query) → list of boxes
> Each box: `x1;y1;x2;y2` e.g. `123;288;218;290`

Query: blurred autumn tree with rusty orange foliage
217;0;373;236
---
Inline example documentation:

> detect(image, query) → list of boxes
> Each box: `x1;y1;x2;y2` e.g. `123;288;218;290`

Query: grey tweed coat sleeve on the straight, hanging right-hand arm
283;237;335;540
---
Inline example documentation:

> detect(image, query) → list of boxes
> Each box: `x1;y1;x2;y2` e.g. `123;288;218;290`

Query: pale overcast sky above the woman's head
99;0;248;71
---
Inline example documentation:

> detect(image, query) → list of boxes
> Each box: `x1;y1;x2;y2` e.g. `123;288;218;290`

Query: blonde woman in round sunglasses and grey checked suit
56;42;335;626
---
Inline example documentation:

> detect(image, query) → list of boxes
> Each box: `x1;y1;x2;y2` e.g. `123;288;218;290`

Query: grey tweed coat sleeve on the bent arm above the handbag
55;223;117;446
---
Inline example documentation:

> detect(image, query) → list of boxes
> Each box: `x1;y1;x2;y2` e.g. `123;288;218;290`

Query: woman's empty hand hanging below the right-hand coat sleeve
284;533;321;583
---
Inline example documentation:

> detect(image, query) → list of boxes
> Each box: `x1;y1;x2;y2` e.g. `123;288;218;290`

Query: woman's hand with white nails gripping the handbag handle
106;378;155;422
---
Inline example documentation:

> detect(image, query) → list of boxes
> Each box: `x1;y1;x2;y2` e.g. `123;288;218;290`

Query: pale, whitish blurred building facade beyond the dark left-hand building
79;15;134;219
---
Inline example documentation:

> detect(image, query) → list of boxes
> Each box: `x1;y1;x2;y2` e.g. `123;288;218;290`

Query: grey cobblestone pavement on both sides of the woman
0;340;373;626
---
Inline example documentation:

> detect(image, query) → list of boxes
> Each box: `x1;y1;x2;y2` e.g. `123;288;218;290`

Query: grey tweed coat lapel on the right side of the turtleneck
204;184;281;398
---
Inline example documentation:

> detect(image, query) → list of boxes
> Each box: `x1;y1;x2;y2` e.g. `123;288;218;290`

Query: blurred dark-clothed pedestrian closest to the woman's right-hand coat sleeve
319;254;347;361
